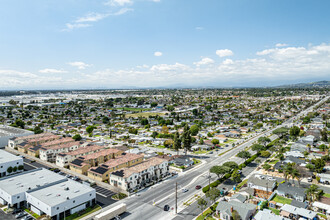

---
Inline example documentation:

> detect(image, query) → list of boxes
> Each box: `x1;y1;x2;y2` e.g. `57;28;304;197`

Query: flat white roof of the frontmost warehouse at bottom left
27;179;95;207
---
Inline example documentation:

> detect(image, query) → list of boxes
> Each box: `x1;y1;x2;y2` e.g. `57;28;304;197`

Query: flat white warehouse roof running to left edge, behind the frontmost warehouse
0;168;67;195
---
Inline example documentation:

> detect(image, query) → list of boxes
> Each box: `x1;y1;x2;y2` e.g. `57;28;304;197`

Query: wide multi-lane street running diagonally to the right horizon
102;98;327;220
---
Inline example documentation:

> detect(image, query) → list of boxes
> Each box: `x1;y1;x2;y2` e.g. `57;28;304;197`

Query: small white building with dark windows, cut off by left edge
0;150;23;177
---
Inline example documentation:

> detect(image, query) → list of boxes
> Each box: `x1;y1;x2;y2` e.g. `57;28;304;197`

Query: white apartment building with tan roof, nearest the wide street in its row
109;157;169;192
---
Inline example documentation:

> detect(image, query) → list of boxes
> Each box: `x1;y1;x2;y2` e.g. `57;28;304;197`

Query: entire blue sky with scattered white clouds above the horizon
0;0;330;89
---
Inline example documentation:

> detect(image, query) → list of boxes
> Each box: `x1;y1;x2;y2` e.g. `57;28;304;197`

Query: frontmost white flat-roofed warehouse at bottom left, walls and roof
26;179;96;220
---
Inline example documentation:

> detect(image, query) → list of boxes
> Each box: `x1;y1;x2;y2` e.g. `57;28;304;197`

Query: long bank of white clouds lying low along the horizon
0;44;330;89
